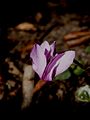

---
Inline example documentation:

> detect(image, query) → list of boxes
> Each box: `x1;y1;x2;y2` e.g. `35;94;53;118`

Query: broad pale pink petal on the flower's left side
30;44;46;78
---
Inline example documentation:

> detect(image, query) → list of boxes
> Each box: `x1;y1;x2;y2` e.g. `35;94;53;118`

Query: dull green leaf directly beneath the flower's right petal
55;70;71;80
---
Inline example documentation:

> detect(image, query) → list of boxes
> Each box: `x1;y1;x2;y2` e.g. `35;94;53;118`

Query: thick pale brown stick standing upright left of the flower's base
21;65;34;109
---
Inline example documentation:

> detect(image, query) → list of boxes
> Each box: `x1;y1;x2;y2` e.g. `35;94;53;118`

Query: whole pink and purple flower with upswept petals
30;41;75;81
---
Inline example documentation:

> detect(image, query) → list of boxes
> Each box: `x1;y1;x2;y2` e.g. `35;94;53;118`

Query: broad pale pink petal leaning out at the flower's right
55;51;75;76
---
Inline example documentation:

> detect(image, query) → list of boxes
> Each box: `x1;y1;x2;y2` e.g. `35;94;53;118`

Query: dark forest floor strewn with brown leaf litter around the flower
0;5;90;114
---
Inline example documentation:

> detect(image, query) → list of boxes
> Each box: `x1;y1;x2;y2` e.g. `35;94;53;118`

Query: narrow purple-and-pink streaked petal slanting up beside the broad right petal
42;53;64;81
